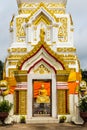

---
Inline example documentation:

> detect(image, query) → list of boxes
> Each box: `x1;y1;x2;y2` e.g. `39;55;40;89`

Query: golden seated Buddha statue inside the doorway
36;84;50;103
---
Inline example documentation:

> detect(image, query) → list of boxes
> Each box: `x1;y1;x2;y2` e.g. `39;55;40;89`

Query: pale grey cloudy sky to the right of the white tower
67;0;87;69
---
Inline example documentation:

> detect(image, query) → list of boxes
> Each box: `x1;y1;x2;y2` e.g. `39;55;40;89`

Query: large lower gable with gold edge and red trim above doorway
17;42;66;72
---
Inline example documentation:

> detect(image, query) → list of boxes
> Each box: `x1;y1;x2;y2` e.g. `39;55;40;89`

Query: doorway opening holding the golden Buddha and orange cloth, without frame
33;80;52;117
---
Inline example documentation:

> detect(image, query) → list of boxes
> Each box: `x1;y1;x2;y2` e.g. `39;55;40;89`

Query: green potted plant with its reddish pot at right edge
79;95;87;122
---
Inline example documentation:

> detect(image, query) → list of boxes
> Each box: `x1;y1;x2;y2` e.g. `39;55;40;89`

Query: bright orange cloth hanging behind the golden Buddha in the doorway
34;81;50;98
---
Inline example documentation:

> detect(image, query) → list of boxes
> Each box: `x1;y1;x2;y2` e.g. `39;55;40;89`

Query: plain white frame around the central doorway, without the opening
27;74;57;119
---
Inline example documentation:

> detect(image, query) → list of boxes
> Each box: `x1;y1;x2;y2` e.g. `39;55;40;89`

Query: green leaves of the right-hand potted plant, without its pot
79;95;87;112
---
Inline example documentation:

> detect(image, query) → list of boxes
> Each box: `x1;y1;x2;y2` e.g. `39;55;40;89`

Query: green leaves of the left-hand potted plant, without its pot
0;100;13;113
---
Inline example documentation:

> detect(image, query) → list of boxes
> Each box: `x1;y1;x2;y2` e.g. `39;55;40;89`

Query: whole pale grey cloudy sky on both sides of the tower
0;0;87;69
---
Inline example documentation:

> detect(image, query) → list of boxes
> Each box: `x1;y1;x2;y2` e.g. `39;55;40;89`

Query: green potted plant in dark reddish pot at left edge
0;100;13;124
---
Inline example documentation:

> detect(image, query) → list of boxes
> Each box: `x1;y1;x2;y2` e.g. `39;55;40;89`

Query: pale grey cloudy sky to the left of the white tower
0;0;17;60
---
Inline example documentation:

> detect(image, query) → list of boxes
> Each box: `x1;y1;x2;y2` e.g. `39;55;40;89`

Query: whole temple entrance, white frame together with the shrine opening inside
27;74;57;120
